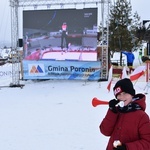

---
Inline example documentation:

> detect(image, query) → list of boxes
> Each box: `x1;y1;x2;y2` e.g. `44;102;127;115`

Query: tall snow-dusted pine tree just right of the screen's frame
109;0;134;65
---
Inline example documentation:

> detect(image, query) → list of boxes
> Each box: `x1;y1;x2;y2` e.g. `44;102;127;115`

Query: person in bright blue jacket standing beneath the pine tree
122;51;135;73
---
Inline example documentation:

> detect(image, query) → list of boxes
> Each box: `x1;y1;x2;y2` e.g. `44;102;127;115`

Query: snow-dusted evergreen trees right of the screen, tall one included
99;0;150;65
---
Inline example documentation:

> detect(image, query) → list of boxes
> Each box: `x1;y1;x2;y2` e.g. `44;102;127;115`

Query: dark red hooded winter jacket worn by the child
100;94;150;150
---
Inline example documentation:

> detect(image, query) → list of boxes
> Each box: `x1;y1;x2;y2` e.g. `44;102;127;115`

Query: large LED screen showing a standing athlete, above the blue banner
23;8;97;61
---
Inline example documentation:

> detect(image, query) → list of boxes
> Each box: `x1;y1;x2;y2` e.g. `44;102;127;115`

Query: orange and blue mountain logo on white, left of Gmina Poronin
28;64;45;76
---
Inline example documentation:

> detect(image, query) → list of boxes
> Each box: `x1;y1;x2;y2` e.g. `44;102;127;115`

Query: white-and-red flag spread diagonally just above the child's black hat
130;66;146;81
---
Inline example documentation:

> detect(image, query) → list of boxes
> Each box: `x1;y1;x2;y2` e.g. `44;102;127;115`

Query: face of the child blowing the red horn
117;92;133;106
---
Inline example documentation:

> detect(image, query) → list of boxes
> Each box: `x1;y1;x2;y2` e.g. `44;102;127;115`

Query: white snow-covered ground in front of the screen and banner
0;47;150;150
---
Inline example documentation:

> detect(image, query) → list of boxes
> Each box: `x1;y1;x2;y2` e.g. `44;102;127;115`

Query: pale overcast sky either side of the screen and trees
0;0;150;46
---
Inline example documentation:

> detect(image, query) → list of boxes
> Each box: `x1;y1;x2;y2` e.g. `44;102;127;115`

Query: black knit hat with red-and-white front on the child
113;78;135;98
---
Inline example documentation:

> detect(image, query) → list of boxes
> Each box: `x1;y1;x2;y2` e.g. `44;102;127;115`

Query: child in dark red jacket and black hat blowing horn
99;78;150;150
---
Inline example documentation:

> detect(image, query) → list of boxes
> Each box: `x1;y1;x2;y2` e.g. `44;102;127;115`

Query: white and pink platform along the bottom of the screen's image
25;46;97;61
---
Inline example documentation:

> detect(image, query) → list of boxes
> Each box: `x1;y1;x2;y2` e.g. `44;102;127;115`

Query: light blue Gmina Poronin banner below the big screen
23;60;101;80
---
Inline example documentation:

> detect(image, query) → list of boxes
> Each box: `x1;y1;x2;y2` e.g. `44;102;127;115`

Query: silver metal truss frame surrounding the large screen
10;0;110;87
